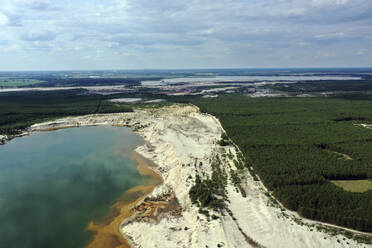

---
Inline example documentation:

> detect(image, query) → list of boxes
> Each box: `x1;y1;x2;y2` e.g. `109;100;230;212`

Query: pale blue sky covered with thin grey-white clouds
0;0;372;70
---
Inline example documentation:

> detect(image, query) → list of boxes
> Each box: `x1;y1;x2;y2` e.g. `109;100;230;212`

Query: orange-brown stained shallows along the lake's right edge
86;152;162;248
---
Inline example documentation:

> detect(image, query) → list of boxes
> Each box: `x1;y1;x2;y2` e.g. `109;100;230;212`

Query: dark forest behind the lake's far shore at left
0;90;133;135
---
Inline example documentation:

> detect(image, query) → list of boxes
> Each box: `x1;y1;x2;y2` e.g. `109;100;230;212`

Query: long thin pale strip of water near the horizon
141;75;360;86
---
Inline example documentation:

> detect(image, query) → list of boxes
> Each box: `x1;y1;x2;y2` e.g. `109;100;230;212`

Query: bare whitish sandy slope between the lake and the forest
26;105;370;248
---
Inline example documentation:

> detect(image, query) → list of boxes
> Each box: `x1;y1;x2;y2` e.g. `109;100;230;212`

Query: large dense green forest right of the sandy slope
192;95;372;232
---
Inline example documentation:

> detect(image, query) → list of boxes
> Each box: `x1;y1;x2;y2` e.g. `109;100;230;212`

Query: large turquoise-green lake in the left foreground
0;127;148;248
